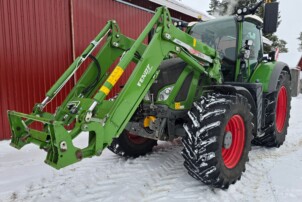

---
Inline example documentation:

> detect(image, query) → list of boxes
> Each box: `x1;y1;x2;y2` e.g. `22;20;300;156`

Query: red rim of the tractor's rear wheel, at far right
276;86;287;133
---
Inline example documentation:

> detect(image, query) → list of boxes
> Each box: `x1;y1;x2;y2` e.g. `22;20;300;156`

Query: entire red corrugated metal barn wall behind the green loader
0;0;196;140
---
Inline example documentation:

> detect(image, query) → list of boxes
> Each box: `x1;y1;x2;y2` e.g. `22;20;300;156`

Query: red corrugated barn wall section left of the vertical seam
0;0;73;139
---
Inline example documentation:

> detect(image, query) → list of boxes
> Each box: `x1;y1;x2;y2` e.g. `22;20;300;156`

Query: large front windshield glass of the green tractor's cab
190;17;237;61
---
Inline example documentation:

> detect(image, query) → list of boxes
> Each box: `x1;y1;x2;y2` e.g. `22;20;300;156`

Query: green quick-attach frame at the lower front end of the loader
8;111;82;169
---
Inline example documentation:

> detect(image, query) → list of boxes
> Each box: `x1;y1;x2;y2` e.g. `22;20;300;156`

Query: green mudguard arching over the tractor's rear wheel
249;61;291;93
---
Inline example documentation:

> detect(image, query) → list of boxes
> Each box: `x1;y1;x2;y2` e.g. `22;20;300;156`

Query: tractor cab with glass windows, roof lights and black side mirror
188;2;278;82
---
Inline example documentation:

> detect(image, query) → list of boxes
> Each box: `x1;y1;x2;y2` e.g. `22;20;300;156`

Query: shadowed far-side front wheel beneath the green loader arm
108;130;157;158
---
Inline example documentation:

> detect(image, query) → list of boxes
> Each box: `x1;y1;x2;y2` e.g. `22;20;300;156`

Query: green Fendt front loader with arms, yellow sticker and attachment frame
8;7;221;169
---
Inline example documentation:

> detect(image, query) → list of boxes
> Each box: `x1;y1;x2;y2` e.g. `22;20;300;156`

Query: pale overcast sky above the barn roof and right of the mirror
179;0;302;67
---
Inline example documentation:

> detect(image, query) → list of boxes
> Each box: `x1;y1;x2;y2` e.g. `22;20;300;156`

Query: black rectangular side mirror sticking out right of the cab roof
263;2;279;34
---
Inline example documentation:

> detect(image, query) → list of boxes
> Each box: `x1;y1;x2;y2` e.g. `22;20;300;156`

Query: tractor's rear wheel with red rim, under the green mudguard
253;71;291;147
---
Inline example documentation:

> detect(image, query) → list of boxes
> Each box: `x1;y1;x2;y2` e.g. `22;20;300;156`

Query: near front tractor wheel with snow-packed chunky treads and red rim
182;93;253;189
